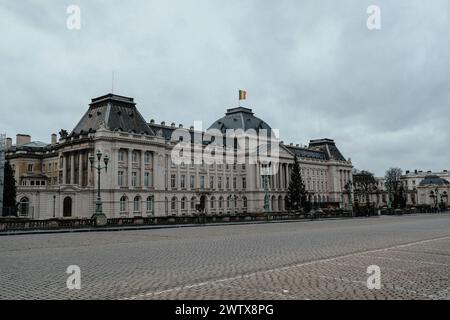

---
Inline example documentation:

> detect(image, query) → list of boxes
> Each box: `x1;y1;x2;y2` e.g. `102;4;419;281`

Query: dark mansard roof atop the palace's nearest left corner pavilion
71;93;154;135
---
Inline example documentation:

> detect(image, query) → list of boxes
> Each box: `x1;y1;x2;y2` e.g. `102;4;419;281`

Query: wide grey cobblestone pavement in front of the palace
0;214;450;299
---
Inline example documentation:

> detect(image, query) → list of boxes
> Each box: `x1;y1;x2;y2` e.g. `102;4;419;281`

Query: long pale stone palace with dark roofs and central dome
6;94;353;219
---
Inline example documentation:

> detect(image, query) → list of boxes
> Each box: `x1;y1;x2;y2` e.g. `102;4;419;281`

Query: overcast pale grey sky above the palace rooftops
0;0;450;175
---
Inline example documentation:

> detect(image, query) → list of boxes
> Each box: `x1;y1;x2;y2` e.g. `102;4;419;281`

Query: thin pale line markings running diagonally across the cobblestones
122;236;450;300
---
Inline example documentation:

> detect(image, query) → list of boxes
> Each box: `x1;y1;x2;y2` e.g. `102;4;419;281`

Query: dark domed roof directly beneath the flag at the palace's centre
209;107;272;135
